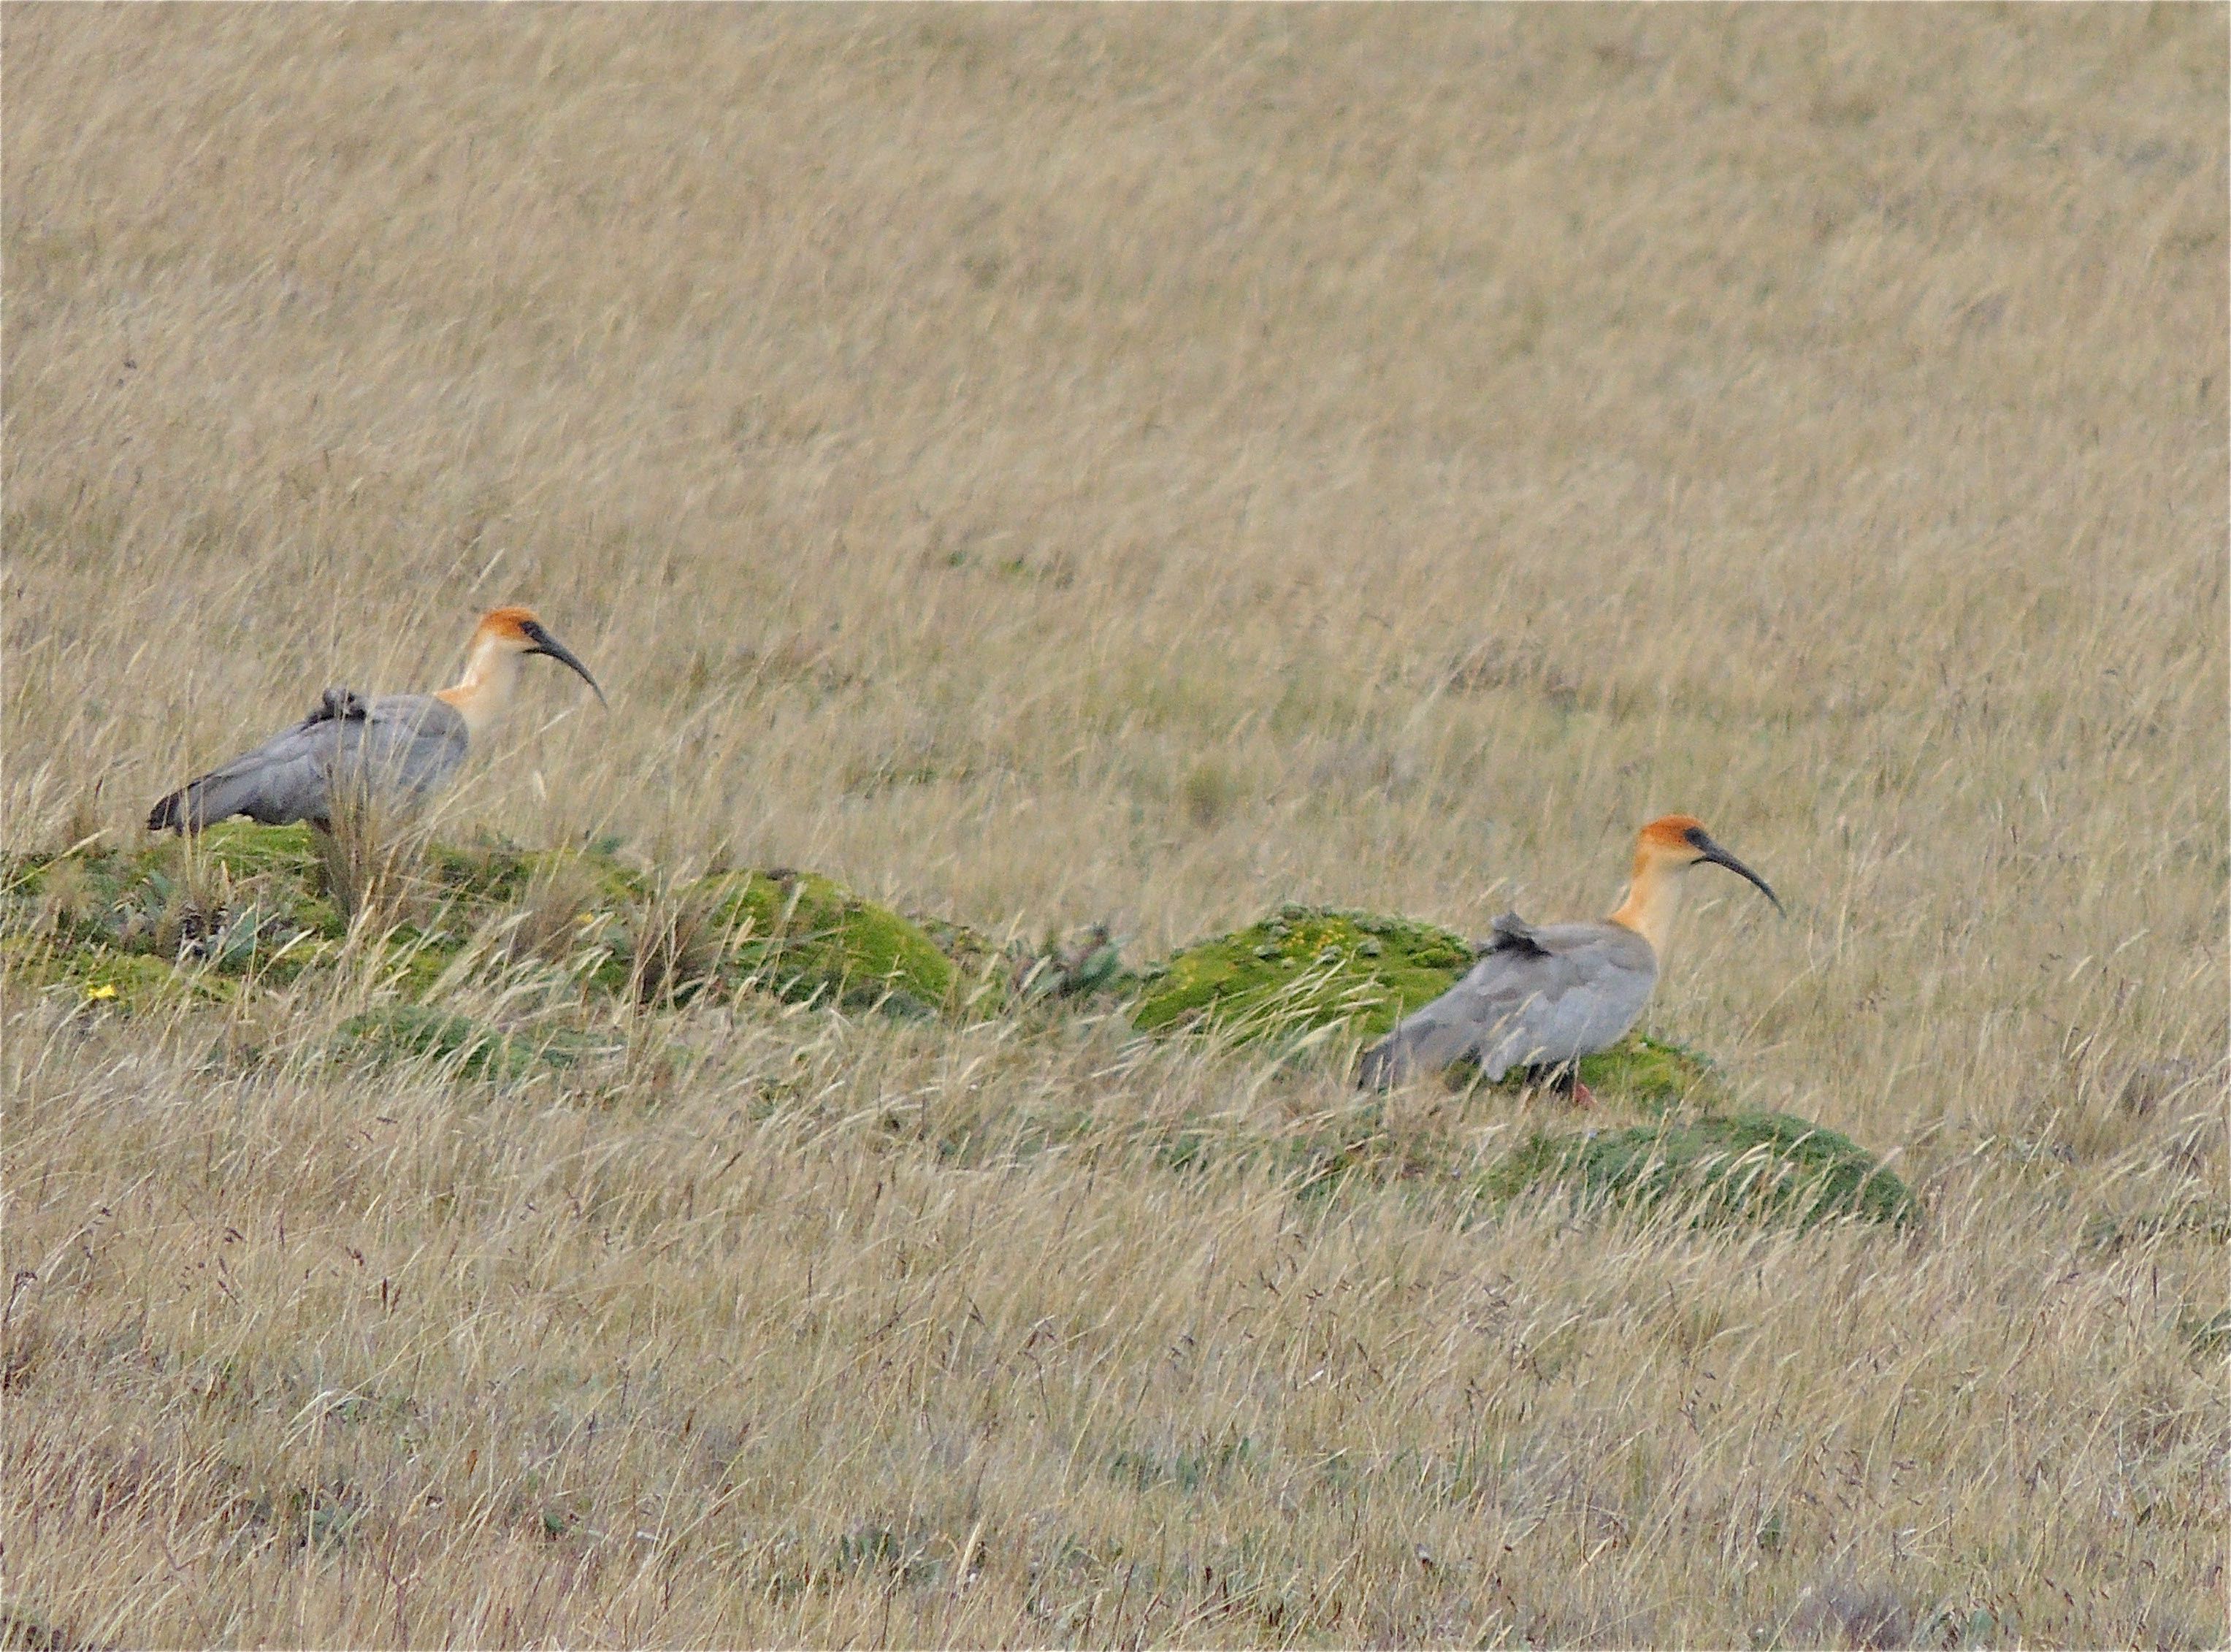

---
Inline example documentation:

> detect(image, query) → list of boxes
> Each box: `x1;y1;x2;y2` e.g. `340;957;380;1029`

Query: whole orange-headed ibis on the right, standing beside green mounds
1361;815;1780;1087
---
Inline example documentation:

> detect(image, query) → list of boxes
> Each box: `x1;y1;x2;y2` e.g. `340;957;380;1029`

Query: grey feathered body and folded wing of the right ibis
1361;913;1658;1087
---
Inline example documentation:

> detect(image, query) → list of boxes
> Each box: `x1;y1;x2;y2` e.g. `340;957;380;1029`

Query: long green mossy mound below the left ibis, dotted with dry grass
0;822;984;1016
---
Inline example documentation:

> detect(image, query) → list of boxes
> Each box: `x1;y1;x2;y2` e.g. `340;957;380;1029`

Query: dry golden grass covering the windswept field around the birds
0;4;2231;1648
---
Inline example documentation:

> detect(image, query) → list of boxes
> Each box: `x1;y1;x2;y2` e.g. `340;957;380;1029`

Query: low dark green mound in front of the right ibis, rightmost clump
1482;1112;1921;1228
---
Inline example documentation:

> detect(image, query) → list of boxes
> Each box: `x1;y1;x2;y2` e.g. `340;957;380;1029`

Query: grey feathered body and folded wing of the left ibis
148;687;466;833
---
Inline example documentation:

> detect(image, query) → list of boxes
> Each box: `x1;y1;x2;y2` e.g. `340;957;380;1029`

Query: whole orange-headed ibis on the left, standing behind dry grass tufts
148;607;605;833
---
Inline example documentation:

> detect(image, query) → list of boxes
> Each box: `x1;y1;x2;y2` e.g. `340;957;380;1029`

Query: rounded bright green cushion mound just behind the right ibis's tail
1131;904;1472;1043
